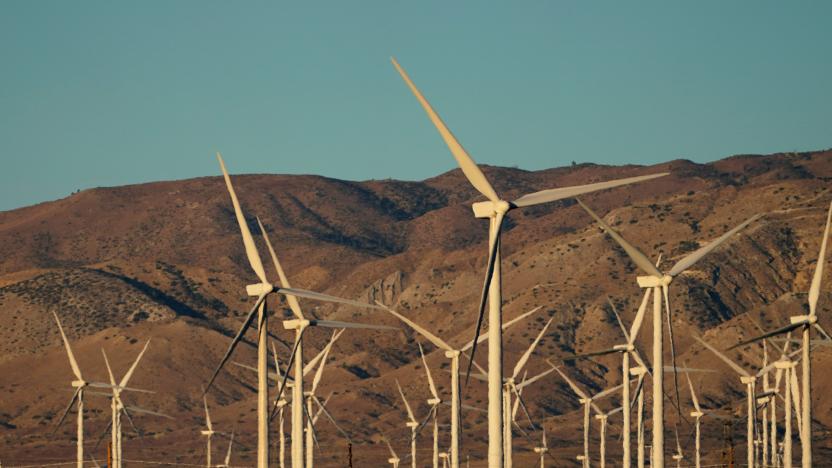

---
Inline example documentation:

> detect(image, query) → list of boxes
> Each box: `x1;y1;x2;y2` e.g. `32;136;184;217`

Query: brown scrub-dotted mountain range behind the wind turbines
0;150;832;467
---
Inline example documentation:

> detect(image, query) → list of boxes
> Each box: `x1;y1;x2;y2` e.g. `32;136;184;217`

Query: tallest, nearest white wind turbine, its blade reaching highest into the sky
392;59;667;468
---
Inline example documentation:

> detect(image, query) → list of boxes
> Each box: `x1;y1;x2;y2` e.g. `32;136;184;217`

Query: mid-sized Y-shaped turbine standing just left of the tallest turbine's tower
376;301;540;468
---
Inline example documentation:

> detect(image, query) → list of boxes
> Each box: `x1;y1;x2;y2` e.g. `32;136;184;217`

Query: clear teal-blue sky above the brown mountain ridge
0;0;832;210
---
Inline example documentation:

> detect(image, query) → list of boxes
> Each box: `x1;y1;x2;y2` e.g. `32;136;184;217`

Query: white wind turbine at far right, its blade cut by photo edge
733;199;832;468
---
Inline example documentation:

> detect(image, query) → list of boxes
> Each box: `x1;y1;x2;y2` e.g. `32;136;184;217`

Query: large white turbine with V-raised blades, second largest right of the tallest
576;199;759;466
